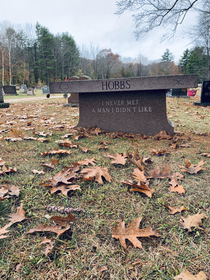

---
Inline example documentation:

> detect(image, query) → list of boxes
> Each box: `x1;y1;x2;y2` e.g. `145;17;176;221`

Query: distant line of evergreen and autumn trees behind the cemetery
0;22;210;86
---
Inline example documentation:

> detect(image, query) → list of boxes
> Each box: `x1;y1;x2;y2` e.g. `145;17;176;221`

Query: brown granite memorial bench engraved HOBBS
49;75;198;136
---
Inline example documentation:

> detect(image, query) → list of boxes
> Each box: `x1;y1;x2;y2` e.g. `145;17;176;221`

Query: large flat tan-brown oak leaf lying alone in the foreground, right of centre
112;217;160;250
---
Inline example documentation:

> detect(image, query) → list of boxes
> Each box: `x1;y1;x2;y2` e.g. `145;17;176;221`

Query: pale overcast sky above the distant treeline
0;0;192;62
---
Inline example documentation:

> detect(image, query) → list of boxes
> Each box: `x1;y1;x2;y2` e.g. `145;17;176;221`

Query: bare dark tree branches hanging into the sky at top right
116;0;202;39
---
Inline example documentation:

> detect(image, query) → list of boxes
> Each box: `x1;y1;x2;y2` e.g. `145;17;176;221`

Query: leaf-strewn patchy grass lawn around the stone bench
0;96;210;280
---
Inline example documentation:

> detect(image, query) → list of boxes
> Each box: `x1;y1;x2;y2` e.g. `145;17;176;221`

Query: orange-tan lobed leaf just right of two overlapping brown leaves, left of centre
80;166;112;185
